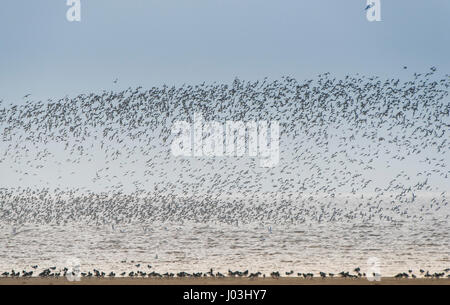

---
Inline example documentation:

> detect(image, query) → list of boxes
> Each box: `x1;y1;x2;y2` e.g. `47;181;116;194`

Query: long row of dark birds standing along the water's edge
1;265;450;279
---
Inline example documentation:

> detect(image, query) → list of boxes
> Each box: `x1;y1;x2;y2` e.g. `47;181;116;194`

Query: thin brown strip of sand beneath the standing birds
0;277;450;285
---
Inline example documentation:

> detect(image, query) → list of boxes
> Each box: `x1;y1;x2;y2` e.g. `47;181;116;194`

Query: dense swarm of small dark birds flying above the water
0;67;450;225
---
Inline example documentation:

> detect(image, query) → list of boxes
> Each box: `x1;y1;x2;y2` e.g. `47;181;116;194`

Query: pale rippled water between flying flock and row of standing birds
0;220;450;276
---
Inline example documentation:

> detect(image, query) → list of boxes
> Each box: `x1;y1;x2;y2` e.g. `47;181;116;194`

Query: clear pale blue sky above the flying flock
0;0;450;103
